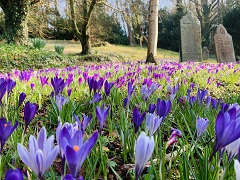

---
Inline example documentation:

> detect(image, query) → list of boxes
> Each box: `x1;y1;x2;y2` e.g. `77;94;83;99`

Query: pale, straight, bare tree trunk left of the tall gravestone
146;0;158;64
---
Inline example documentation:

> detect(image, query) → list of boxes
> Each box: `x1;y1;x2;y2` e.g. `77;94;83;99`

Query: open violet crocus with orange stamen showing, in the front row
65;131;98;178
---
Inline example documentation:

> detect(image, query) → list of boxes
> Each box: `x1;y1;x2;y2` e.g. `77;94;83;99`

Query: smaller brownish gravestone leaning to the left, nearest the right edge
214;24;236;63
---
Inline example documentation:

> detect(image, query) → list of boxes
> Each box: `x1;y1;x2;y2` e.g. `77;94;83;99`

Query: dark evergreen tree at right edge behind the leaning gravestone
223;6;240;56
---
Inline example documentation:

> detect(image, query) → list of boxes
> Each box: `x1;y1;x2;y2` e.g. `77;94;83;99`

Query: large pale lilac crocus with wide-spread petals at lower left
17;127;59;179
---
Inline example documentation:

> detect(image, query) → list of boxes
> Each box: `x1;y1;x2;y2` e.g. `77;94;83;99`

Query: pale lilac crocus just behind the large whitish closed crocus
146;113;162;136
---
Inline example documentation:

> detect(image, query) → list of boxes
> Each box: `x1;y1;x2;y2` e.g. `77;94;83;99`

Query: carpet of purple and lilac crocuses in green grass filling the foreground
0;60;240;180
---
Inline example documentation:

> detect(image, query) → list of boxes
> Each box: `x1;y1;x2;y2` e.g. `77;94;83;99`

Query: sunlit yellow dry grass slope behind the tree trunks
45;41;179;61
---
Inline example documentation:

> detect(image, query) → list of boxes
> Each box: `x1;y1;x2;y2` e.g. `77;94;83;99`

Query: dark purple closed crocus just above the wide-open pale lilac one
24;101;38;131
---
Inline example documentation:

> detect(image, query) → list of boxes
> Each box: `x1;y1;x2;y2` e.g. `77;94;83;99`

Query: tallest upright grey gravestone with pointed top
180;11;202;62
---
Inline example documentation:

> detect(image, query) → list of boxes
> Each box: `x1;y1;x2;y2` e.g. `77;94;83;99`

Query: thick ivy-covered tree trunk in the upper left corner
2;0;29;45
